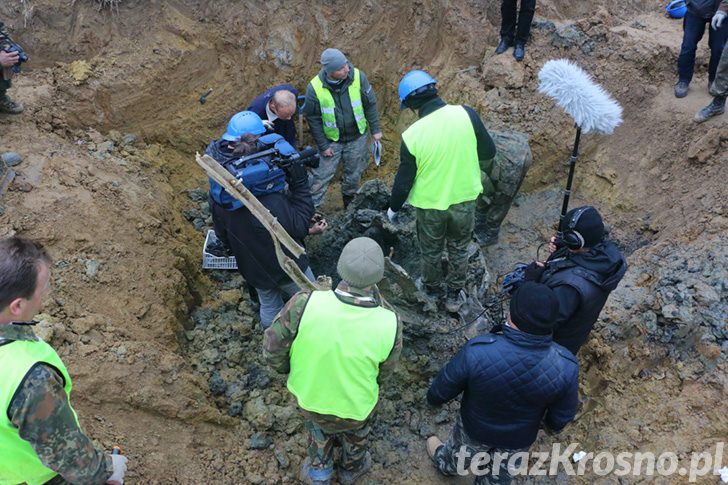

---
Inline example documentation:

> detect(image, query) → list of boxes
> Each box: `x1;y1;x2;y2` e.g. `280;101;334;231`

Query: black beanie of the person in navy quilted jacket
510;281;559;335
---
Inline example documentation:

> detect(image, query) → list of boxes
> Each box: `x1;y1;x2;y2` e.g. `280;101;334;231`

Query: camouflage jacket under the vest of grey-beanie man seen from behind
263;281;402;431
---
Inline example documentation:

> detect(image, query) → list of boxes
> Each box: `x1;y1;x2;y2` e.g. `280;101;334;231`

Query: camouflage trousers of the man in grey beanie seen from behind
305;416;371;471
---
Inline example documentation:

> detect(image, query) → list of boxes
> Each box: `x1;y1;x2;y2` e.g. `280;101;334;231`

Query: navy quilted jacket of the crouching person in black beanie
427;327;579;449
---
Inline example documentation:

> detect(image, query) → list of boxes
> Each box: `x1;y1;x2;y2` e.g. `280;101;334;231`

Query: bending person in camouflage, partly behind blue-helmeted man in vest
475;130;533;246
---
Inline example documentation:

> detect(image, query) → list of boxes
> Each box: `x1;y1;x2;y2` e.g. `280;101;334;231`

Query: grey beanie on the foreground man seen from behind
336;237;384;288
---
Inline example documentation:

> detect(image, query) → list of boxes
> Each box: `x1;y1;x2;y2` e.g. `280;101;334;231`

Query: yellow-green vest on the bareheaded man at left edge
0;340;78;485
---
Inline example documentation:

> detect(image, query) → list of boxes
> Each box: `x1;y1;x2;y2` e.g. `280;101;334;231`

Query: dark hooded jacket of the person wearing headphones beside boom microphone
540;241;627;355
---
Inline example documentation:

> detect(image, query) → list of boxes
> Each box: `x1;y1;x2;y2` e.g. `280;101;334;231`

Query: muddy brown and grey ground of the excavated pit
0;0;728;483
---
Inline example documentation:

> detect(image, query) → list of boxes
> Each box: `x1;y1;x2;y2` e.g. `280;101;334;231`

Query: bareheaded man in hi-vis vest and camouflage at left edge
0;237;126;485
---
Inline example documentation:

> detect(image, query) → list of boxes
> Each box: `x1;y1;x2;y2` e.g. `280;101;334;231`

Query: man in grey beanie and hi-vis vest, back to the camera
263;237;402;485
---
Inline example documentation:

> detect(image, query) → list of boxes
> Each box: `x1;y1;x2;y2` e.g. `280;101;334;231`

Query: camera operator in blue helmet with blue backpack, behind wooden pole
206;111;318;328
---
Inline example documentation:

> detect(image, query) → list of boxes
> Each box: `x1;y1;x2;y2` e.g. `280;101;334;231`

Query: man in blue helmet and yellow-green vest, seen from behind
387;70;496;313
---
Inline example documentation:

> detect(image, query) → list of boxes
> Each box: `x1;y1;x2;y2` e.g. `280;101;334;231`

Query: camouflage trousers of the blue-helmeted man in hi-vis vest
417;200;475;290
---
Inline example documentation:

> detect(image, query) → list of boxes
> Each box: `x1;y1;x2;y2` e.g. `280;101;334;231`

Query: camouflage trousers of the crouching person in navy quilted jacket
433;413;528;485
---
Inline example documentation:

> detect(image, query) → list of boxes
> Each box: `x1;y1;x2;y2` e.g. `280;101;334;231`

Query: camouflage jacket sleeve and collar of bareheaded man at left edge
0;325;113;484
